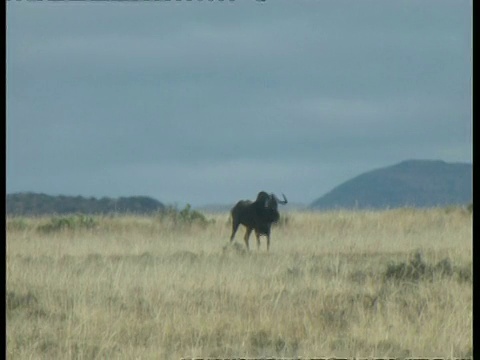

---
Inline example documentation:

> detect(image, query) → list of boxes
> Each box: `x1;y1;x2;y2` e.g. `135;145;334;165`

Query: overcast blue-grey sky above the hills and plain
6;0;472;206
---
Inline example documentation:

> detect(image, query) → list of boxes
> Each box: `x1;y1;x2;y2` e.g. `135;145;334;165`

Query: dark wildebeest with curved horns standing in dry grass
230;191;287;251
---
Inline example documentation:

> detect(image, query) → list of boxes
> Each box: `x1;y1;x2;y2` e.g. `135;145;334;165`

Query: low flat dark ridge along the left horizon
6;193;165;216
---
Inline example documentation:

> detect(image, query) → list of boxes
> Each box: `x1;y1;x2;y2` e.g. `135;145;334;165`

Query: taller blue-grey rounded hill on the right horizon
310;160;473;210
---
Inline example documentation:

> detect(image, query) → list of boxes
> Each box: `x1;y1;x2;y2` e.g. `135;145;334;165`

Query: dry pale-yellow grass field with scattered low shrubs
6;208;473;359
